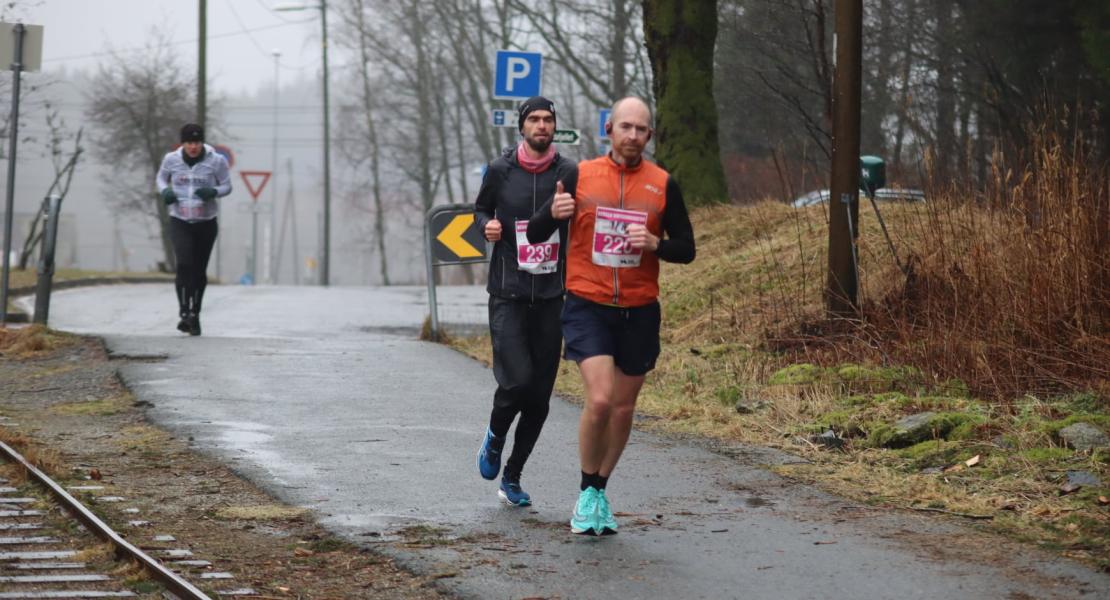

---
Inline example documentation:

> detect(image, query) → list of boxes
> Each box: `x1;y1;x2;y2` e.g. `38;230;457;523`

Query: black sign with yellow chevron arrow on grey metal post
424;204;487;342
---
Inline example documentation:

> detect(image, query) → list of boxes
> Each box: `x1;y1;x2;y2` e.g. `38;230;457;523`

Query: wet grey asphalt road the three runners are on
19;285;1110;599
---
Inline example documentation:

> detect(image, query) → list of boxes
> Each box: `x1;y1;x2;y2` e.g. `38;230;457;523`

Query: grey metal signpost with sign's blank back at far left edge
0;23;42;324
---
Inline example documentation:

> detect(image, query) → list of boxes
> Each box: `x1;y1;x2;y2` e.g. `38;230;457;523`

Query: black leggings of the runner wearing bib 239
490;296;563;478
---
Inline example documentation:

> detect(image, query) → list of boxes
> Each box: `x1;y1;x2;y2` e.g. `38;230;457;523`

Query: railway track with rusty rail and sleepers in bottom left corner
0;434;255;600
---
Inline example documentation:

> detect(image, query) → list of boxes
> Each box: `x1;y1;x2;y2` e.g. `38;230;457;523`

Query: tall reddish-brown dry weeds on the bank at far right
865;128;1110;401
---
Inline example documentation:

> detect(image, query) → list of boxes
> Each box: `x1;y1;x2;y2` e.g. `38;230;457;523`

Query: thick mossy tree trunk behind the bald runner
643;0;728;205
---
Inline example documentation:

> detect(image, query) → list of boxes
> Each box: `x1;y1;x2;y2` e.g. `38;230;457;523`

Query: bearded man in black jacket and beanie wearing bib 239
474;96;577;506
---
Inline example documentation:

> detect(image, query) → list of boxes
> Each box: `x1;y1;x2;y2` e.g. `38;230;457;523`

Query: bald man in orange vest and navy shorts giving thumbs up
527;98;695;535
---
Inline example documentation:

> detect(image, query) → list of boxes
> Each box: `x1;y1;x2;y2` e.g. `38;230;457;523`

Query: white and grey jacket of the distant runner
154;144;231;222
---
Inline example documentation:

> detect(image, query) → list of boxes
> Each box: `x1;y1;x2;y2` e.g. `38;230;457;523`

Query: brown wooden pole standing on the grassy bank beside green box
825;0;864;317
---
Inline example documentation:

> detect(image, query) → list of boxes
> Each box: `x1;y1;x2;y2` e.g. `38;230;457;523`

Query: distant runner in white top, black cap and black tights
154;123;231;335
